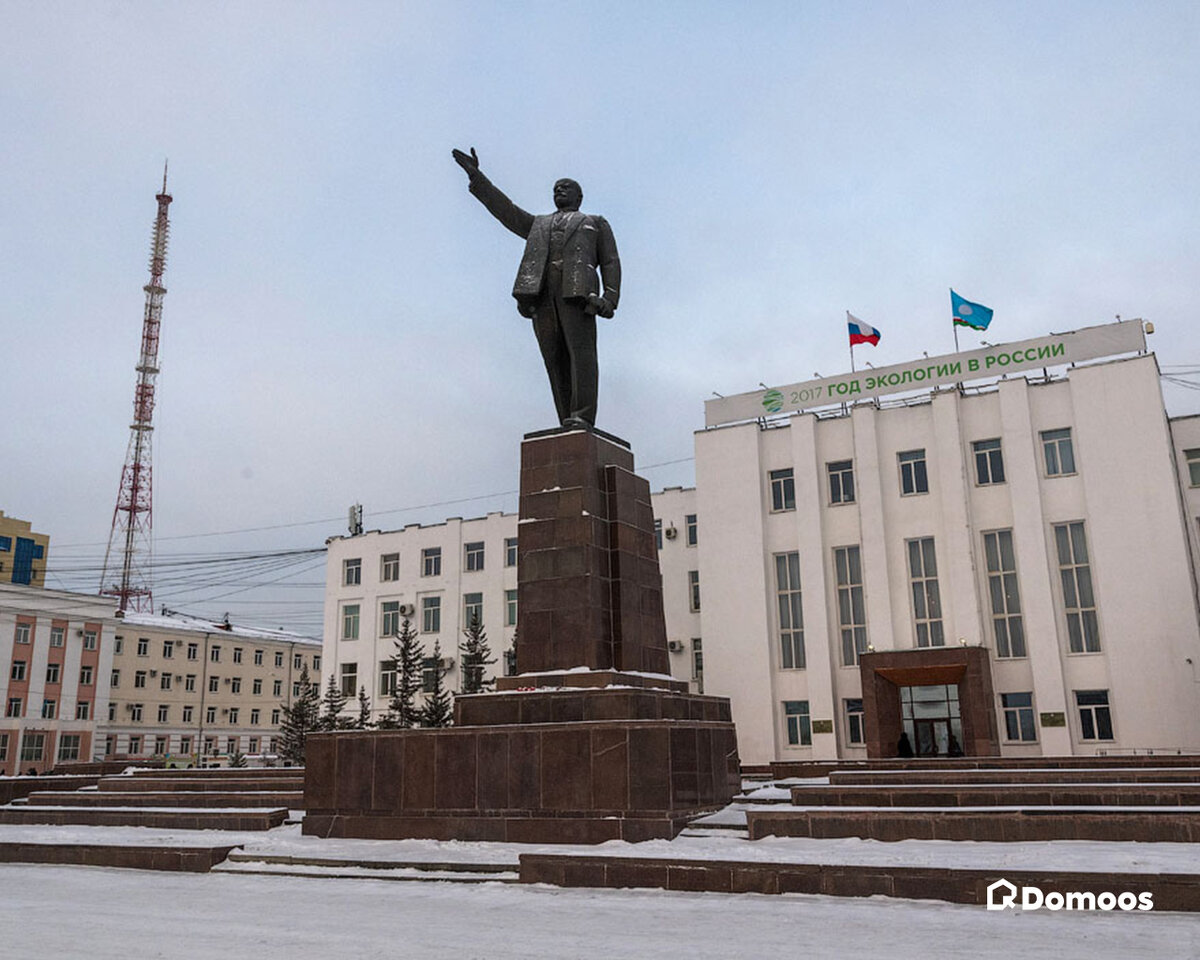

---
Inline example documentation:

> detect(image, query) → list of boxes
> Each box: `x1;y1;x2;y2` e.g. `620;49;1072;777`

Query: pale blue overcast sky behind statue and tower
0;0;1200;638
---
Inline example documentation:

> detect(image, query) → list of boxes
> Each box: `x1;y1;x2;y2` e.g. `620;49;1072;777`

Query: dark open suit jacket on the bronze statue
470;173;620;310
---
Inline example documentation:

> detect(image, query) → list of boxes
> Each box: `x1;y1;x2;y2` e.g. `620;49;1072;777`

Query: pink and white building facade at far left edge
0;583;115;776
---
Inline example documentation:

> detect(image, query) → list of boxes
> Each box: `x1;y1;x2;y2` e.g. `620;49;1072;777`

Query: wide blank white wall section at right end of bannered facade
1069;356;1200;750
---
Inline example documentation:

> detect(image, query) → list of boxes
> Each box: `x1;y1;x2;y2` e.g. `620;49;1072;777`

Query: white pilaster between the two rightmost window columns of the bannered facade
998;377;1074;756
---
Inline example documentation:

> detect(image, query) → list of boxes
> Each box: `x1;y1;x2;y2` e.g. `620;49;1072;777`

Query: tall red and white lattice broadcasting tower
100;164;170;613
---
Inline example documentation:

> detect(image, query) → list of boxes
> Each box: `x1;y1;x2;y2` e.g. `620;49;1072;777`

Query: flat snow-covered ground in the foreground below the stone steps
0;864;1200;960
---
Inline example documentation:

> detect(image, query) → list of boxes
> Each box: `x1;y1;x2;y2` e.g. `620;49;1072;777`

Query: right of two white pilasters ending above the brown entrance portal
926;390;985;646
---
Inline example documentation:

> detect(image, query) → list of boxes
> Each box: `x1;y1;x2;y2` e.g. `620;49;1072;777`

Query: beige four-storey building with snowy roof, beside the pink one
105;613;320;762
